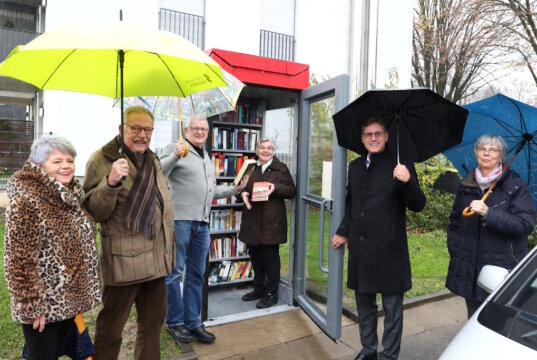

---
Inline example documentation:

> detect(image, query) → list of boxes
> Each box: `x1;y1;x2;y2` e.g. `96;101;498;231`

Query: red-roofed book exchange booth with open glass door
202;49;353;339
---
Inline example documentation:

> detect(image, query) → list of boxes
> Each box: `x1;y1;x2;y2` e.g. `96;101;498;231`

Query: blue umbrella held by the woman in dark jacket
444;94;537;211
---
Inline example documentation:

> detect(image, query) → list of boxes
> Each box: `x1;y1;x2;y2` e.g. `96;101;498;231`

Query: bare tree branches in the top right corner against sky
487;0;537;85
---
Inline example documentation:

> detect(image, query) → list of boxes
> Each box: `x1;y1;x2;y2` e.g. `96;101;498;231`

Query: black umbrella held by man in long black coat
332;88;468;162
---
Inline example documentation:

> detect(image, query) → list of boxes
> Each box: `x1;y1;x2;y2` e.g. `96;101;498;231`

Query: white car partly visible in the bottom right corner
440;247;537;360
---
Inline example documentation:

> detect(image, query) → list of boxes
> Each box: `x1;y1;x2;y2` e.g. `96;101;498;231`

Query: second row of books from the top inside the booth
212;127;261;151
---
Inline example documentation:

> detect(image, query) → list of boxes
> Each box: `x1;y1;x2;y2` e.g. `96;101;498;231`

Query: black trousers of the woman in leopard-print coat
22;317;75;360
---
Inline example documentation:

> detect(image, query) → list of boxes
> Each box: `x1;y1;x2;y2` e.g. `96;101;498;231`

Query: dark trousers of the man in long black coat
356;292;403;359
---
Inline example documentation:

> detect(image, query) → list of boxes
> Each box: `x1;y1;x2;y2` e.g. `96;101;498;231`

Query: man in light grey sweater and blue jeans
157;117;248;343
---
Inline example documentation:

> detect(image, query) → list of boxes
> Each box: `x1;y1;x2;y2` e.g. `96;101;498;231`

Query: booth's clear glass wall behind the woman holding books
263;108;296;281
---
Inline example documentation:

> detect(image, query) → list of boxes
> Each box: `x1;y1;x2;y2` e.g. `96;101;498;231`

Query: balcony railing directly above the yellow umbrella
159;9;205;50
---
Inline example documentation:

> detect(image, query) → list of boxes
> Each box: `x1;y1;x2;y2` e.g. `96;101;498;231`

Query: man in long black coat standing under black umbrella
332;118;425;360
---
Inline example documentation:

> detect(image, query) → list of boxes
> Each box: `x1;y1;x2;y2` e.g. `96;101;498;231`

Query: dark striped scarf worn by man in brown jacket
123;146;161;239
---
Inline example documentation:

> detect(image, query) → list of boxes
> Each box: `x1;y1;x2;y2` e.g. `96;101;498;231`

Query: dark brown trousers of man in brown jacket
95;277;166;360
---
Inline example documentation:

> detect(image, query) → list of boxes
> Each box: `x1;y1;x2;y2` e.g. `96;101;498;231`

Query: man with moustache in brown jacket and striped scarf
84;106;175;360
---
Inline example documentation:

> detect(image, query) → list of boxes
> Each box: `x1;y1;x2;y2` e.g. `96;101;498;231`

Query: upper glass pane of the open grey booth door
308;97;334;198
